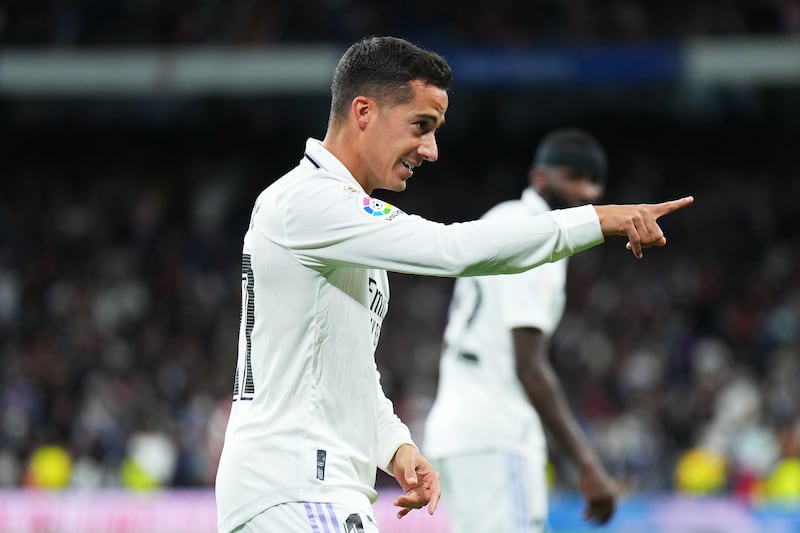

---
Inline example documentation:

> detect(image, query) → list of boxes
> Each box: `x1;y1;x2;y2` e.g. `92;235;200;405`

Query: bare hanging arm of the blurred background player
511;327;617;524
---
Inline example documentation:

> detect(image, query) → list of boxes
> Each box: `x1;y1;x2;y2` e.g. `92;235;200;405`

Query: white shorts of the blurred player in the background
435;451;547;533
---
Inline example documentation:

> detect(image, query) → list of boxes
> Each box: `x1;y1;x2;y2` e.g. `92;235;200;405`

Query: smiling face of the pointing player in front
354;80;448;194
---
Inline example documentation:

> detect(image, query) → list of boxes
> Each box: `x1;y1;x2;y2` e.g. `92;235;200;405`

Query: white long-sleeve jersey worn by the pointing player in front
216;139;603;531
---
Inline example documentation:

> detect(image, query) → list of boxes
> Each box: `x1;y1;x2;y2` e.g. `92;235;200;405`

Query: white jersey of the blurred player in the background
423;188;567;459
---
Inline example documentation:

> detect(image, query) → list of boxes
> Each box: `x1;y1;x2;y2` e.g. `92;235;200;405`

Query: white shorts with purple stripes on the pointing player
234;502;378;533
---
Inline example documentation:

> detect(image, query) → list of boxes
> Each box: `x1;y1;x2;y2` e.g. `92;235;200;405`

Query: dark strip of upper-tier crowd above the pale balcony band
0;0;800;47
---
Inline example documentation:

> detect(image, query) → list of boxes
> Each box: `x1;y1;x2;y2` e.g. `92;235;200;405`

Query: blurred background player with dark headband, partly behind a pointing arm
423;129;616;533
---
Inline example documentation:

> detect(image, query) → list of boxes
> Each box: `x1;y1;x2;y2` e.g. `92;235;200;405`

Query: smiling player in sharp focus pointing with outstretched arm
216;37;692;533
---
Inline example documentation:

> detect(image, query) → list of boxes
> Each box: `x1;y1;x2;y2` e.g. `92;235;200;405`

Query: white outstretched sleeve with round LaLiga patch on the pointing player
264;174;603;276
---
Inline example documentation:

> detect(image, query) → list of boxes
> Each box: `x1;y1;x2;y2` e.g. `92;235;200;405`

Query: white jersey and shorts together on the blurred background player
423;188;567;533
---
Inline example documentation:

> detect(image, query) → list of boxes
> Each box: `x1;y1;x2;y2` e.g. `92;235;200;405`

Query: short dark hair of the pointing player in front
331;37;453;120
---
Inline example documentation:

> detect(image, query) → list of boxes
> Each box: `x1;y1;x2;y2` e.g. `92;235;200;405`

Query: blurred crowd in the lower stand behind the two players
0;86;800;500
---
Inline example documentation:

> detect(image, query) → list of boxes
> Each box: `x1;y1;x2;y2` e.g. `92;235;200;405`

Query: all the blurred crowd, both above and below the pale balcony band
0;0;800;508
